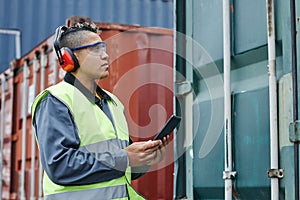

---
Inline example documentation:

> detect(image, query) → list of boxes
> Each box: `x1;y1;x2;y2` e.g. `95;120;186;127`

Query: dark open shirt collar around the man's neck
64;73;114;104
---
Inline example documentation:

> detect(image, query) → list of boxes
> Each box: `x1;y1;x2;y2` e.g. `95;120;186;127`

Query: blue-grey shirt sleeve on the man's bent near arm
33;93;128;185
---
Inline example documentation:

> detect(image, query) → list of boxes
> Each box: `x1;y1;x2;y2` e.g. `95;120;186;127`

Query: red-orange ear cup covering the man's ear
61;47;79;72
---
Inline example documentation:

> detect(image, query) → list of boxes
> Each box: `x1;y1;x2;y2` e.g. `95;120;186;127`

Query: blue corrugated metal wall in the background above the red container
0;0;173;72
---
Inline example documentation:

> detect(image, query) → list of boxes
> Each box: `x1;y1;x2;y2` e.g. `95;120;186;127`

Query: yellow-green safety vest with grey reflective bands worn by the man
32;81;144;200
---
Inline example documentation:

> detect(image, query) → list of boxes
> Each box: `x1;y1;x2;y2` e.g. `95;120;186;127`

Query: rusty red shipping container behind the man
1;17;174;199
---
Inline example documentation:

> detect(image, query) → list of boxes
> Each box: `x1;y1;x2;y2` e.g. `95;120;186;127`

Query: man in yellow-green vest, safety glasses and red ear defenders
32;23;169;200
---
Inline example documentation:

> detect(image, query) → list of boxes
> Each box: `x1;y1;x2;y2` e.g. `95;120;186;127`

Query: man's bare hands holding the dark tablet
125;137;169;167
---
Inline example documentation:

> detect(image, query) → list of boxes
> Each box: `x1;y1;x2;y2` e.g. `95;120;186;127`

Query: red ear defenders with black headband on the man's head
53;26;79;72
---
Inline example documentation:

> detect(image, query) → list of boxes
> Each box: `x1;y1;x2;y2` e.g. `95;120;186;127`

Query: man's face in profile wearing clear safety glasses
74;32;109;80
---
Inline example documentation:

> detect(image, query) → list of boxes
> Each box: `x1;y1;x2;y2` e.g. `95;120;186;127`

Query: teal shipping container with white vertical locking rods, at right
174;0;300;200
